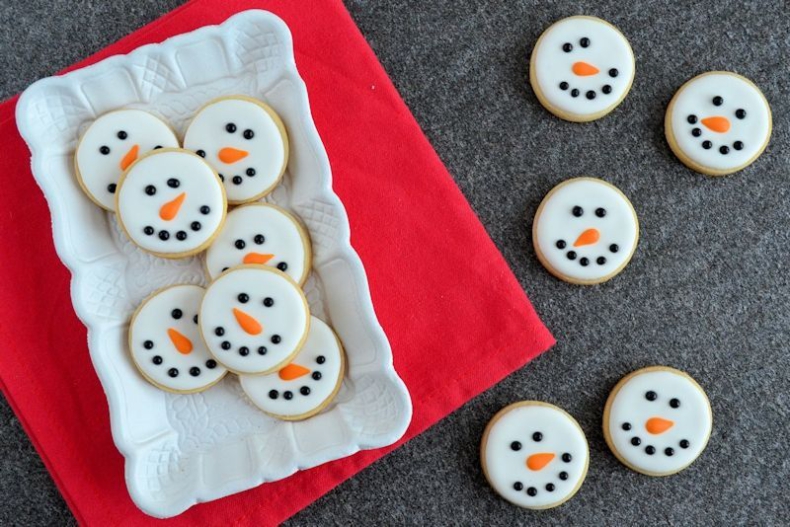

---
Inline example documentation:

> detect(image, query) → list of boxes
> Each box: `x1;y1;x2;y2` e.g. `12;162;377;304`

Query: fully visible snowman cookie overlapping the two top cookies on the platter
116;149;227;258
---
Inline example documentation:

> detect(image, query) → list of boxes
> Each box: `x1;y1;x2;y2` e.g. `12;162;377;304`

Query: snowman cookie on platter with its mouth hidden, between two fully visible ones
206;203;312;284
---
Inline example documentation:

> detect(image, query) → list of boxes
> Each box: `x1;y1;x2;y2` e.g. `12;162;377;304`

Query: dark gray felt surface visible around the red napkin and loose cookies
0;0;790;525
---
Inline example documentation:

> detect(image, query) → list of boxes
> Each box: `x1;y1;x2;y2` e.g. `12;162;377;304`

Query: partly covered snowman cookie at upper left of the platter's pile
74;110;178;211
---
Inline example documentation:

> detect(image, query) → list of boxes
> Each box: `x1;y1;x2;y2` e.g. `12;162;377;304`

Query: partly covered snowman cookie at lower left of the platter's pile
129;285;227;393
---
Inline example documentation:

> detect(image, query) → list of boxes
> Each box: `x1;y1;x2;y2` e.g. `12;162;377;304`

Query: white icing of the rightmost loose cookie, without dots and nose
670;73;771;170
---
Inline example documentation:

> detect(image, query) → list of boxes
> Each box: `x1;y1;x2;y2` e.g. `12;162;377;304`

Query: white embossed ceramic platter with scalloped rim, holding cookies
16;11;412;517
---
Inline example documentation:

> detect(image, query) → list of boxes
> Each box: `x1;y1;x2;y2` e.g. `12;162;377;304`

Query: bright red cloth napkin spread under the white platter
0;0;554;526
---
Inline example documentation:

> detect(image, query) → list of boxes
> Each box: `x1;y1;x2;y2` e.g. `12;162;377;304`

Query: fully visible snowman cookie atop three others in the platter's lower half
200;265;310;374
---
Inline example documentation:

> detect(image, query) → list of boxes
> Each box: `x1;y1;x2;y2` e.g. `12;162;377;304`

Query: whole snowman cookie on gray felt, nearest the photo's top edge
529;16;636;122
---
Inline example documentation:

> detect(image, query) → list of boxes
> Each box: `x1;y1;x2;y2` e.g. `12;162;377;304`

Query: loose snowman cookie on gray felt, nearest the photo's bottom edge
480;401;590;509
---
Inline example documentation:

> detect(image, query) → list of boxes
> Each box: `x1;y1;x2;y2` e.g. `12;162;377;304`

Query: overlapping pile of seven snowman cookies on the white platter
74;96;345;420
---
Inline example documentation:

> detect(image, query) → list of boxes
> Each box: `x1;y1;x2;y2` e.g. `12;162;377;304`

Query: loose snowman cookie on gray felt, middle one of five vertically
532;178;639;284
